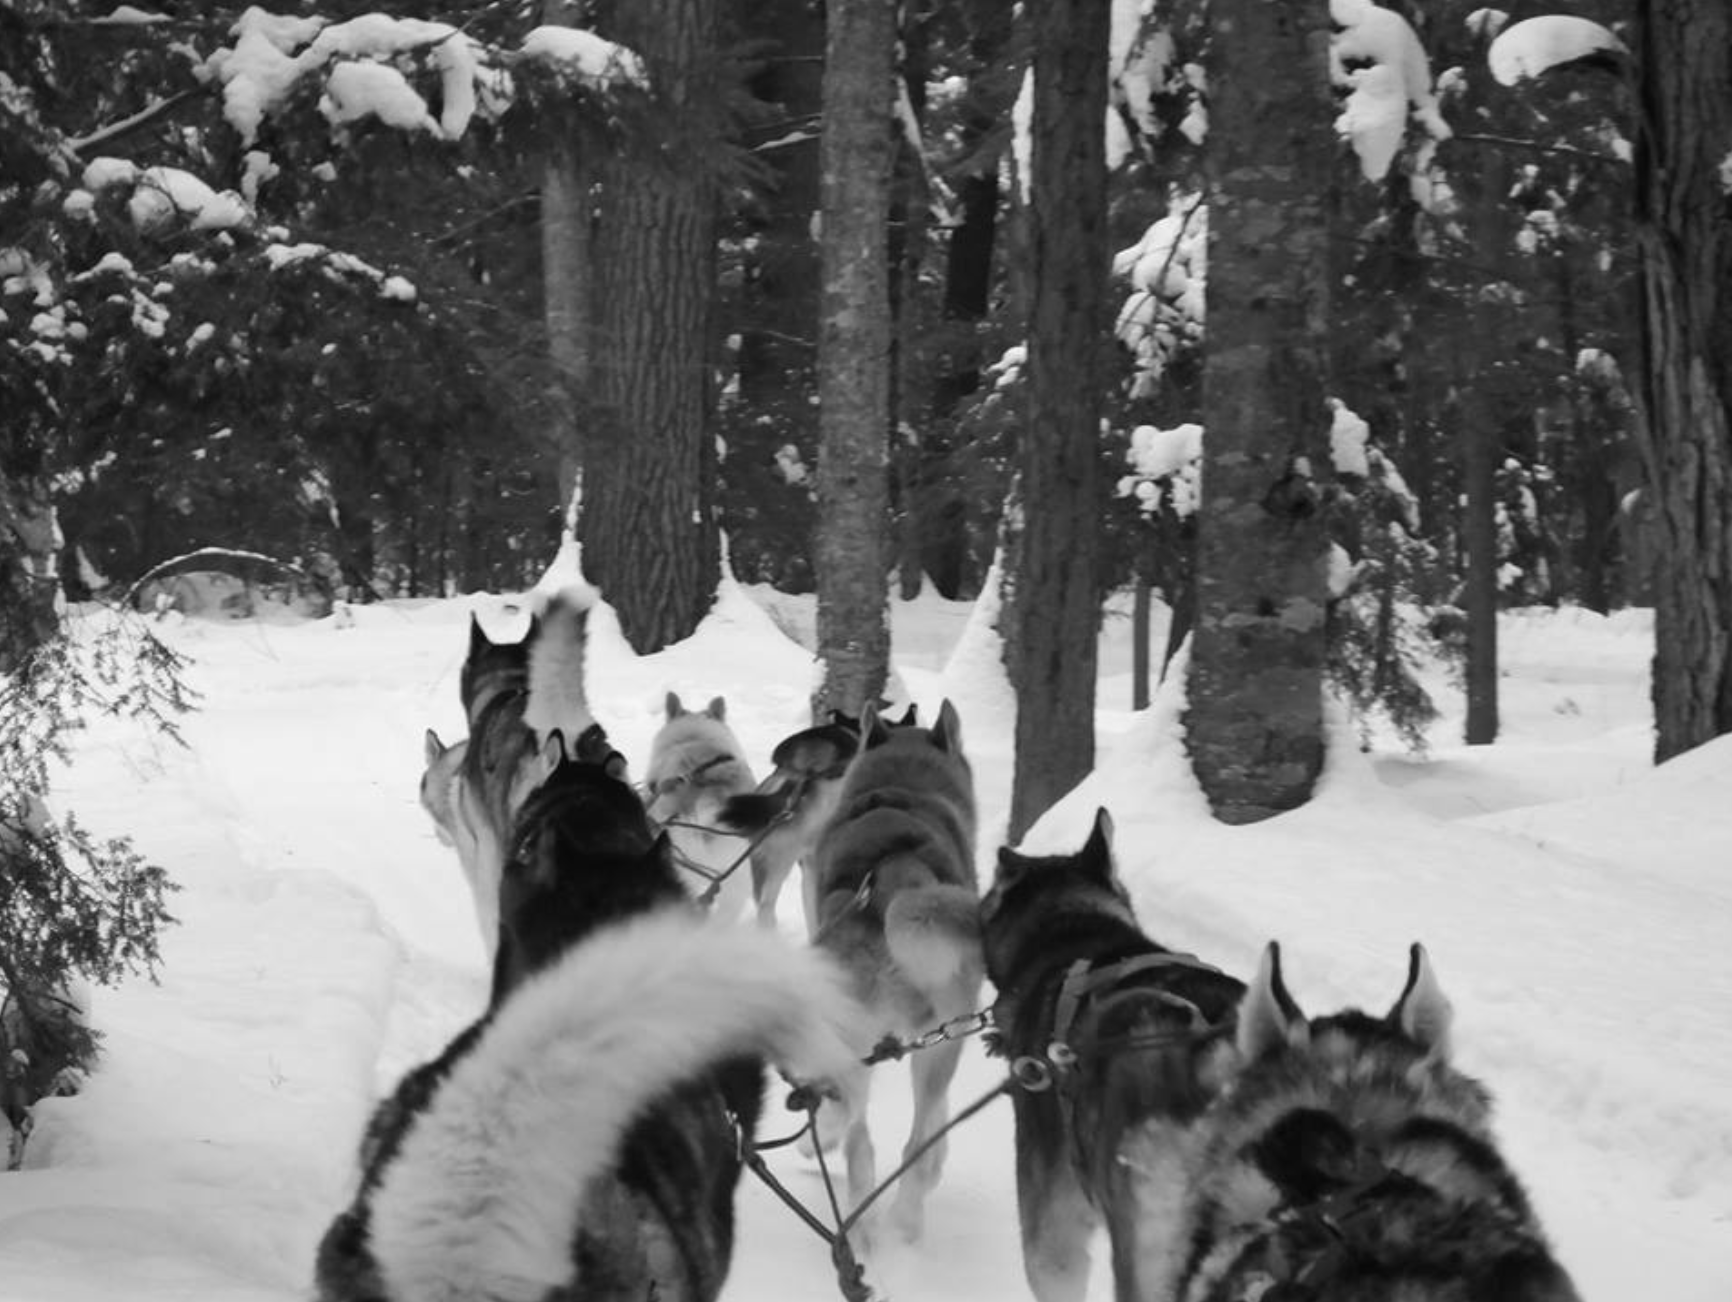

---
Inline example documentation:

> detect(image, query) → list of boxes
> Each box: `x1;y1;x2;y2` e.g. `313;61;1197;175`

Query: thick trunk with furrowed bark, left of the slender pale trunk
578;0;721;653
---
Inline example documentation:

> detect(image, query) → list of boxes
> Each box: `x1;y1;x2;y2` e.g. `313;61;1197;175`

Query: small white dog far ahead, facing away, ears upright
644;693;753;923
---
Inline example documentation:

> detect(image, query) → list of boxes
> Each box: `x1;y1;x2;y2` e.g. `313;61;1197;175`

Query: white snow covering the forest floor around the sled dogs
0;585;1732;1302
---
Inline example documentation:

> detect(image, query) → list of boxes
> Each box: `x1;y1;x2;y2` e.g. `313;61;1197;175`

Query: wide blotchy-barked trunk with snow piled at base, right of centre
1186;0;1334;822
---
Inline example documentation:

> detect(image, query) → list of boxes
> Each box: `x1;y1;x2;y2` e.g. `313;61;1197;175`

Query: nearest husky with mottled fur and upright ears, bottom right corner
1133;942;1580;1302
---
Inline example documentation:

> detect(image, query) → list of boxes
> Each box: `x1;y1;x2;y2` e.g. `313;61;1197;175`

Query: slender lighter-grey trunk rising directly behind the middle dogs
812;0;895;717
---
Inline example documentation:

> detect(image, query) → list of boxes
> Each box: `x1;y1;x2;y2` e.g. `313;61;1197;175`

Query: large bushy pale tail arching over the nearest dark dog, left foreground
371;909;861;1302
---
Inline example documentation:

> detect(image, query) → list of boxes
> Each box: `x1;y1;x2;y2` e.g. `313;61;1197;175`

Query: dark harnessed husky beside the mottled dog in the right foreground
980;809;1245;1302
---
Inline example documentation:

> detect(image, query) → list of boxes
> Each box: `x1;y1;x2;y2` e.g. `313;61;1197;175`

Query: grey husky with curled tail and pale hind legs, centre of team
809;701;986;1240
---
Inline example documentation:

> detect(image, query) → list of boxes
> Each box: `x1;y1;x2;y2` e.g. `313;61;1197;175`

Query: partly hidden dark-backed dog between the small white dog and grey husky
721;706;916;935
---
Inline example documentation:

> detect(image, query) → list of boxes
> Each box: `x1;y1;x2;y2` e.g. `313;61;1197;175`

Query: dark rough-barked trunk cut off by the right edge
1635;0;1732;760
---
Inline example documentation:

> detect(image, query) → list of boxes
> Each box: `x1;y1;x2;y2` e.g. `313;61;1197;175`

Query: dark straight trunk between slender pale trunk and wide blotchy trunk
1010;0;1112;841
